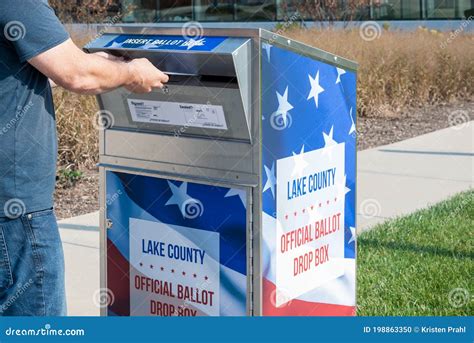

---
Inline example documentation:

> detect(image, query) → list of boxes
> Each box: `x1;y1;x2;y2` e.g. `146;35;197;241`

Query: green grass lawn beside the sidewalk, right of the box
357;191;474;316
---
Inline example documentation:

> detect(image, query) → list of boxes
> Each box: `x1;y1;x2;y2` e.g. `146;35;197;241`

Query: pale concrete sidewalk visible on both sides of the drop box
59;121;474;316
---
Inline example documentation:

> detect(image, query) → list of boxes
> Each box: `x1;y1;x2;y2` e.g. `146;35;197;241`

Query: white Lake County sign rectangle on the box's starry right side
275;143;346;307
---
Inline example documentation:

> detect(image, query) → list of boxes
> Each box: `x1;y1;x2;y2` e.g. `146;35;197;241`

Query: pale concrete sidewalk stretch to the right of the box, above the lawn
357;121;474;232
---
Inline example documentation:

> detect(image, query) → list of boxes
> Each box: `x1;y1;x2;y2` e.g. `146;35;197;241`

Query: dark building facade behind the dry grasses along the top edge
113;0;474;23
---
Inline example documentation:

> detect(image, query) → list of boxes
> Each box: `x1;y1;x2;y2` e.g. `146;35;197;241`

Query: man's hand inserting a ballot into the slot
125;58;169;93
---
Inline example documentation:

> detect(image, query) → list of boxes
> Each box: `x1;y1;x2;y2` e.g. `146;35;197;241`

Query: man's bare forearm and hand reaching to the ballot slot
28;39;168;94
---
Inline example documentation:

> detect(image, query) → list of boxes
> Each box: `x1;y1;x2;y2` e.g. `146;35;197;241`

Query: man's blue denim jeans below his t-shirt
0;209;66;316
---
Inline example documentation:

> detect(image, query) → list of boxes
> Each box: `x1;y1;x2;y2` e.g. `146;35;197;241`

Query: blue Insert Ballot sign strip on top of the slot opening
104;35;227;51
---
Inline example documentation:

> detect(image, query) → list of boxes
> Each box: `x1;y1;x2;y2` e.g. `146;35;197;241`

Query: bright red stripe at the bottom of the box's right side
263;278;355;316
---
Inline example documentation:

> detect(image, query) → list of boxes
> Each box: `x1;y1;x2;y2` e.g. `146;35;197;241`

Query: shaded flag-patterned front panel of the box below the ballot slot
106;171;247;316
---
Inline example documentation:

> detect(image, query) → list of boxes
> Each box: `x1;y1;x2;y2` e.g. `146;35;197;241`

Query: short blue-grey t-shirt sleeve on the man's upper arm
0;0;69;62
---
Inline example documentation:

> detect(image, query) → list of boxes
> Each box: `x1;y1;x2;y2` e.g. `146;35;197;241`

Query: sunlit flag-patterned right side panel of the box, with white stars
261;42;356;316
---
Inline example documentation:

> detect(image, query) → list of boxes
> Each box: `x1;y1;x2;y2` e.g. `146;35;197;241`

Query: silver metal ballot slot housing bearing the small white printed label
85;35;252;143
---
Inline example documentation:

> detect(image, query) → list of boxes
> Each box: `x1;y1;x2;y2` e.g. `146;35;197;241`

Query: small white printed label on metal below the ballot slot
127;99;227;130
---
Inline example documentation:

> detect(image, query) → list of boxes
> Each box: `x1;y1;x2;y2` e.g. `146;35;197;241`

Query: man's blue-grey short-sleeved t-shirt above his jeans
0;0;69;217
